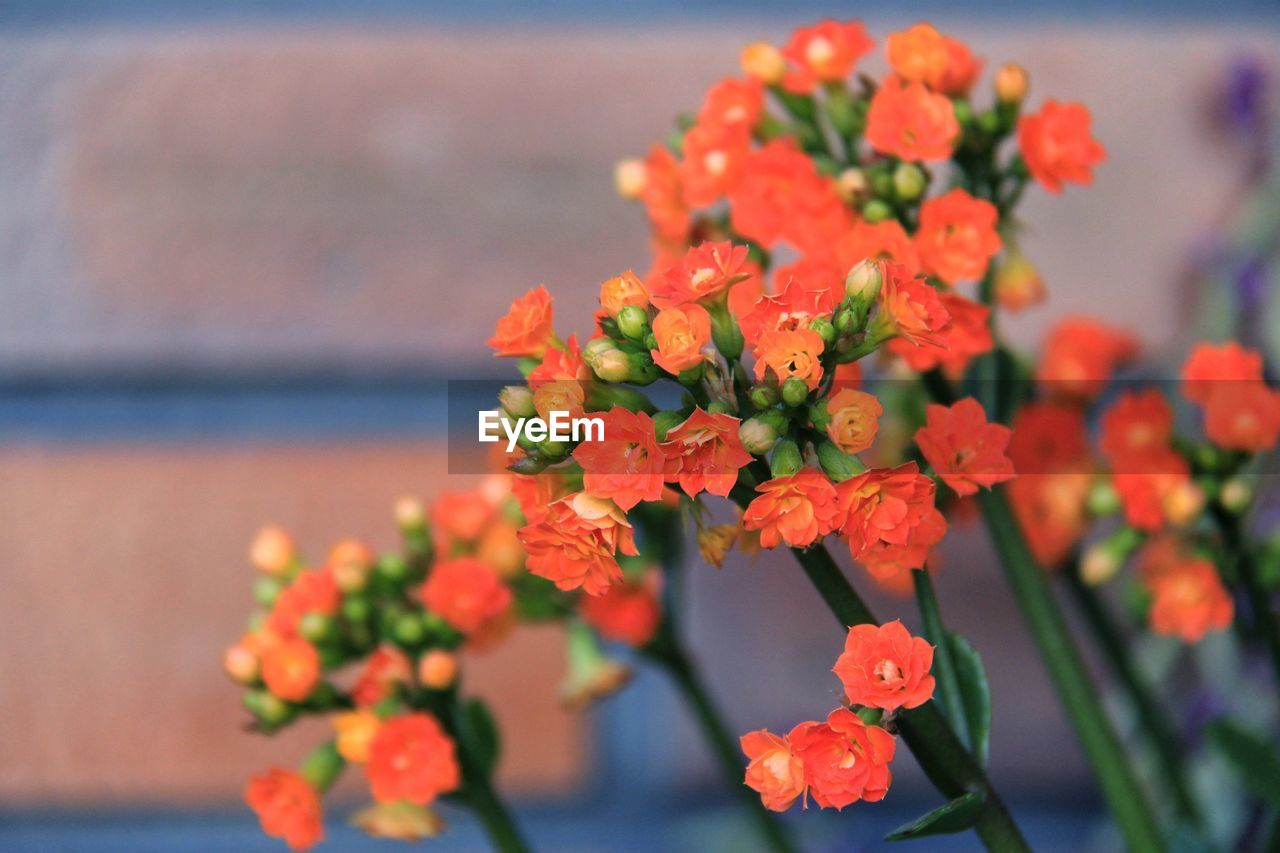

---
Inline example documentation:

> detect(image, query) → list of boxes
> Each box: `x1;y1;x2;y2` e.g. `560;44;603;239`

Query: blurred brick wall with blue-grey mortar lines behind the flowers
0;0;1280;850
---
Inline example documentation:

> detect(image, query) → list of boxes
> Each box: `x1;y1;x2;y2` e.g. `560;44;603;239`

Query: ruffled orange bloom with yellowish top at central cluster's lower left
520;492;637;596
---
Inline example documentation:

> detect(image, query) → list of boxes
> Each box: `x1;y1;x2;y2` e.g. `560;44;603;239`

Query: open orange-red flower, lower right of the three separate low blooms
788;708;897;809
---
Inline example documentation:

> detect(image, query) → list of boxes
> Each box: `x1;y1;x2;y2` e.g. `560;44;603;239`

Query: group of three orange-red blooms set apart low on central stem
741;621;933;812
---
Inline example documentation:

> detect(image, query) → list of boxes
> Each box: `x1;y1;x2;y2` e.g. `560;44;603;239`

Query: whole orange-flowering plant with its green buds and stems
233;20;1280;849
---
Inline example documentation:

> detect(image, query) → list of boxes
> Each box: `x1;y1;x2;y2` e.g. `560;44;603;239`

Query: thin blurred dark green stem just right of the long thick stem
1064;566;1203;825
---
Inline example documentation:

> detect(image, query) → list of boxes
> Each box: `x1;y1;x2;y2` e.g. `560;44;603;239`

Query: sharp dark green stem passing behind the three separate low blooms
791;544;1030;852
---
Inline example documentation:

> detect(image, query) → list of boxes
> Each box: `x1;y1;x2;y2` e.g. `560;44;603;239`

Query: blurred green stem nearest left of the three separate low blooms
646;637;795;853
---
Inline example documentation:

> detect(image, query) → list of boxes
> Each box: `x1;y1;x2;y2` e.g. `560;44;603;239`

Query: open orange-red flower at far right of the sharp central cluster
915;397;1014;494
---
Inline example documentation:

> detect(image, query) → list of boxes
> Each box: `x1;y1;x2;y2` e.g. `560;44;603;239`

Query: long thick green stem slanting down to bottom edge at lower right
978;488;1165;850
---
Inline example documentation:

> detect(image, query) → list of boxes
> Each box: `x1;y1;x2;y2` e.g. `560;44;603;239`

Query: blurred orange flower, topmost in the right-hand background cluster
1036;316;1138;401
